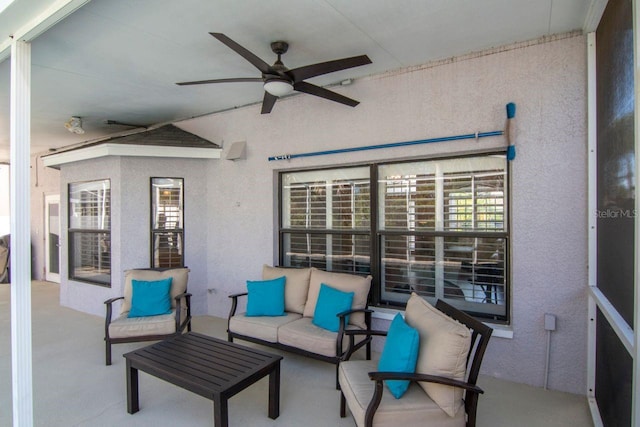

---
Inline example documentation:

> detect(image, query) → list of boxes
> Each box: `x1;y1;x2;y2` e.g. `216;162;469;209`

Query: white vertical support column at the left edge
10;40;33;427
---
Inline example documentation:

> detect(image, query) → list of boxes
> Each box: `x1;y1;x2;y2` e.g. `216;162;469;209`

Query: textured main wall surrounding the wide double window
179;35;587;393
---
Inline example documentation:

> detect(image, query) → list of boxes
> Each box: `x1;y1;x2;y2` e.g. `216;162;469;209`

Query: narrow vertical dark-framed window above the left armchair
151;178;184;268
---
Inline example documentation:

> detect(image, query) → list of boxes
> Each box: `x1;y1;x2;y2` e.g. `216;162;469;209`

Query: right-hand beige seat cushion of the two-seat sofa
278;317;364;357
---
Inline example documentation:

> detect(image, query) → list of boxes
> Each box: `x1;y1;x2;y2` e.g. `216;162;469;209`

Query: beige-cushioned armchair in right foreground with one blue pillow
339;293;493;427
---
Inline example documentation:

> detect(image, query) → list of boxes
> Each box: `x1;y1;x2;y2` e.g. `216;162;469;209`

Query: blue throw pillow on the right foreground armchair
378;313;420;399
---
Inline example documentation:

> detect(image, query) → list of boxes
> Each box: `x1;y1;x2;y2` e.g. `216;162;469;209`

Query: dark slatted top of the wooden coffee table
125;332;282;399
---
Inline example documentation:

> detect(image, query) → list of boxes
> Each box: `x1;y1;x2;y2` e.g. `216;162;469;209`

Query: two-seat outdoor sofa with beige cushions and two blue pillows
227;265;372;385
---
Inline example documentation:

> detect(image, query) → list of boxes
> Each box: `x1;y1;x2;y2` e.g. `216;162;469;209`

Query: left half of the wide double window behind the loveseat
281;168;371;273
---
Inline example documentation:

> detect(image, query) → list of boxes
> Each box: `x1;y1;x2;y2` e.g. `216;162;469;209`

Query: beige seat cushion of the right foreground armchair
338;360;465;427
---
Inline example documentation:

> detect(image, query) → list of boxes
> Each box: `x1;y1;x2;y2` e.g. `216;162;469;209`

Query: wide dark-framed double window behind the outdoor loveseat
280;153;509;320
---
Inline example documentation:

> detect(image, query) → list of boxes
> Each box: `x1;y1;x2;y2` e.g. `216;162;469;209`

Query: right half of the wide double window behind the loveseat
378;156;507;317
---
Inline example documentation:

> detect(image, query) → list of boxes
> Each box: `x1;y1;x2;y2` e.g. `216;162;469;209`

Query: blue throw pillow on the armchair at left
128;277;173;317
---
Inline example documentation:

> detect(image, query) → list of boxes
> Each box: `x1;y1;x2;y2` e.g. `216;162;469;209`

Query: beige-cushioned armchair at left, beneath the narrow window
104;267;191;365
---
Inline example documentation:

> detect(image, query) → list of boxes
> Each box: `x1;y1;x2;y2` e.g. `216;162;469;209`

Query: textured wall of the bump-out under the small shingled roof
60;157;208;316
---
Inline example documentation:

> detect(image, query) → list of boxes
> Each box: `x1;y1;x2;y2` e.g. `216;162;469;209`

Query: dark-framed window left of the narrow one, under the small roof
68;179;111;286
